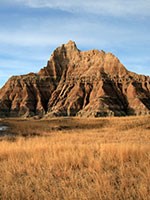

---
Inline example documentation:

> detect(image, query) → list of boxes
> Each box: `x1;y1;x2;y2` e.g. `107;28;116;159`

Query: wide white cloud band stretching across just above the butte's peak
0;15;149;48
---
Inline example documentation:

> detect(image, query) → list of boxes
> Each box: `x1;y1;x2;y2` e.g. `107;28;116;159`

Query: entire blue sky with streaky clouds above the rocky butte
0;0;150;87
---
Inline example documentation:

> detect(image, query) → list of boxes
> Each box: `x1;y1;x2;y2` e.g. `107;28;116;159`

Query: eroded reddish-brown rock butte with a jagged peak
0;41;150;117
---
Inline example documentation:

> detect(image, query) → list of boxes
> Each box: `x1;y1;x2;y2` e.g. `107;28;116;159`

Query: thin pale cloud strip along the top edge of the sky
5;0;150;17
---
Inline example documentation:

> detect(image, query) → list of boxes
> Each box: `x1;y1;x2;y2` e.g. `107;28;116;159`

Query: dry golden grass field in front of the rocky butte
0;116;150;200
